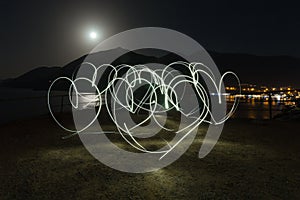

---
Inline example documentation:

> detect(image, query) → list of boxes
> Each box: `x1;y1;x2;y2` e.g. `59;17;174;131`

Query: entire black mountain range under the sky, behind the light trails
0;48;300;90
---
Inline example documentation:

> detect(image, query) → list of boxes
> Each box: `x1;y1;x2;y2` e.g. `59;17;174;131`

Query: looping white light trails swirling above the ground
48;61;240;159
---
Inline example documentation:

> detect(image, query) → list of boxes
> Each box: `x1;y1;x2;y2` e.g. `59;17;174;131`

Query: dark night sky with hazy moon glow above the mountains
0;0;300;83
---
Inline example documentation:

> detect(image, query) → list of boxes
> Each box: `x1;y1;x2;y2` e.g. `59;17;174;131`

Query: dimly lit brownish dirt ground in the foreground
0;116;300;199
